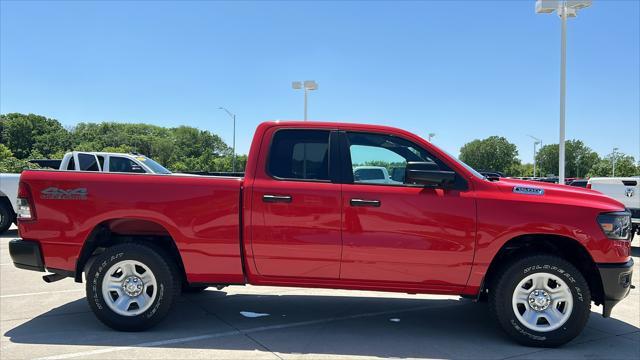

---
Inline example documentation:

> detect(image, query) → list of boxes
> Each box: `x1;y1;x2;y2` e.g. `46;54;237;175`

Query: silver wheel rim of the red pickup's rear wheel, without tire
102;260;158;316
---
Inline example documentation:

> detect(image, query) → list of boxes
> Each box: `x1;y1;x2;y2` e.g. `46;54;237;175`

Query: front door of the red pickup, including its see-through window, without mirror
340;132;475;288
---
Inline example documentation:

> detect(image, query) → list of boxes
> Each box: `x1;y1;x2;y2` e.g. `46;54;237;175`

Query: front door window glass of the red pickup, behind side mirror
347;133;439;185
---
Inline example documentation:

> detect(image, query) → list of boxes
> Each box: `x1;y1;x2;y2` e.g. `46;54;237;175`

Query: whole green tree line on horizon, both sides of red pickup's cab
0;113;640;177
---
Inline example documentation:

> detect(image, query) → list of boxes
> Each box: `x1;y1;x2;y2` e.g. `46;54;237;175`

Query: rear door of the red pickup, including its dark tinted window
249;128;342;279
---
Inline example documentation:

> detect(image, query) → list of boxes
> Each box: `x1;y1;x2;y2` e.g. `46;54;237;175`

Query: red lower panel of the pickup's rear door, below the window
251;180;342;279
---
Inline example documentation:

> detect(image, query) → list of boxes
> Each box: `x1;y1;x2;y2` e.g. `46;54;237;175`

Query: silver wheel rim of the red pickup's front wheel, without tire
512;273;573;332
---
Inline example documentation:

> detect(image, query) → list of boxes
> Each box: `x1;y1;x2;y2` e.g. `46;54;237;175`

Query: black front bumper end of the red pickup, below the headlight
598;259;633;317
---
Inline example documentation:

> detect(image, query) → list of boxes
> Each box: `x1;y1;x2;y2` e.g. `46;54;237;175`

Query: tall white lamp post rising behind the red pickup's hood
536;0;591;184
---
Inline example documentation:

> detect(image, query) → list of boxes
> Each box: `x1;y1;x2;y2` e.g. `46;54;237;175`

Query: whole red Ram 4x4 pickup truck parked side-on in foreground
9;122;633;346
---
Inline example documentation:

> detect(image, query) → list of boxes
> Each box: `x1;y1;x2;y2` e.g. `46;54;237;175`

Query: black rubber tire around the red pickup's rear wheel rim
86;243;180;331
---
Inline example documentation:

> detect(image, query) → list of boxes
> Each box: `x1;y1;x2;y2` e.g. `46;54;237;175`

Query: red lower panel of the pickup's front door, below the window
340;184;475;286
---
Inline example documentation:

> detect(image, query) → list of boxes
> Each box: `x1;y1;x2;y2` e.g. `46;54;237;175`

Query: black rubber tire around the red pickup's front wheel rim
489;255;591;347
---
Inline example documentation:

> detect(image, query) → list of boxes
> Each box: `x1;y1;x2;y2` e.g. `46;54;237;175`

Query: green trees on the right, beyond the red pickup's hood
460;136;640;178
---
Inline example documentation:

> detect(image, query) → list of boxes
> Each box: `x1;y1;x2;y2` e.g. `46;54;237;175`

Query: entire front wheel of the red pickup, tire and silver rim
489;255;591;347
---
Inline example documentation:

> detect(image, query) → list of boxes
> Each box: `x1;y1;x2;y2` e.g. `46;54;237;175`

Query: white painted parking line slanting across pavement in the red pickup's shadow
36;305;444;360
